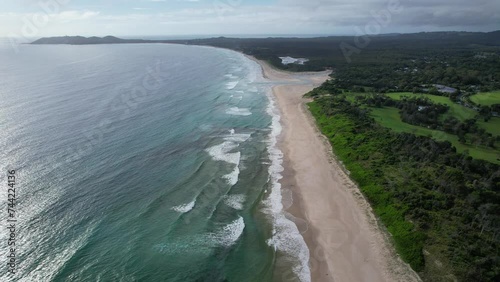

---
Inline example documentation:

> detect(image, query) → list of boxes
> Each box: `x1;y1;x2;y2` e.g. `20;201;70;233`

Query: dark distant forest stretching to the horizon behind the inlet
180;31;500;92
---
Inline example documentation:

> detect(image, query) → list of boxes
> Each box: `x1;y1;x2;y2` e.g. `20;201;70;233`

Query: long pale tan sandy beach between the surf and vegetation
249;57;420;282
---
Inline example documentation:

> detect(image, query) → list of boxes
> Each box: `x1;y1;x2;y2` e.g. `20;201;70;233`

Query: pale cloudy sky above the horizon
0;0;500;37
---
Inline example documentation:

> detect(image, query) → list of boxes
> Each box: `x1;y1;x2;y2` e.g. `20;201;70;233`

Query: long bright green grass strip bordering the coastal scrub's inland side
371;108;500;164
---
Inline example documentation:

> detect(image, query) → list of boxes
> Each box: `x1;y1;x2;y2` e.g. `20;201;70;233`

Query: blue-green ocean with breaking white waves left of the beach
0;41;309;281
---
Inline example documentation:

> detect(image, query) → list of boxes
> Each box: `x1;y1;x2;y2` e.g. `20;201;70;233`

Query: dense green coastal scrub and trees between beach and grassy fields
309;96;500;281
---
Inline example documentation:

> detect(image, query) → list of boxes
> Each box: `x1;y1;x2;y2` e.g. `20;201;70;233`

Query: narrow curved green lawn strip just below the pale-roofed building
387;92;477;121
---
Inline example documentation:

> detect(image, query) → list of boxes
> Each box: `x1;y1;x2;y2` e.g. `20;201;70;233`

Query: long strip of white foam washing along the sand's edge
263;87;311;282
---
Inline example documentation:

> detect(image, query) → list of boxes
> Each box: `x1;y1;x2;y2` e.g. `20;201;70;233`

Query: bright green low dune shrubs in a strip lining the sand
309;102;425;271
